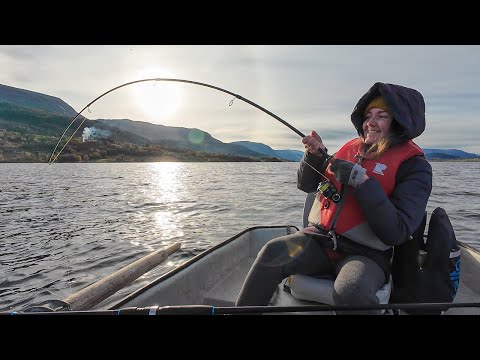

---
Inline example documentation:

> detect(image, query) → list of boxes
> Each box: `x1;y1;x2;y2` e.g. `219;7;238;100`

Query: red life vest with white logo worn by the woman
308;138;423;250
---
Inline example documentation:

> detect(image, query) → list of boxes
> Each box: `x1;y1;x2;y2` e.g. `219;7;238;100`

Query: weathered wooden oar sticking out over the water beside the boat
63;243;181;310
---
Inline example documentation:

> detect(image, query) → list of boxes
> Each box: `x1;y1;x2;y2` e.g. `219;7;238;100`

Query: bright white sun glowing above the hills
133;66;182;124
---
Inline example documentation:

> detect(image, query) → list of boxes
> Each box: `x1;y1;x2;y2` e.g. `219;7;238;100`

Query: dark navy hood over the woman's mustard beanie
351;82;425;139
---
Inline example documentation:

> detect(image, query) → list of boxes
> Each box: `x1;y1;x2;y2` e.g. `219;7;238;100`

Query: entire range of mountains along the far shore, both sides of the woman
0;84;480;162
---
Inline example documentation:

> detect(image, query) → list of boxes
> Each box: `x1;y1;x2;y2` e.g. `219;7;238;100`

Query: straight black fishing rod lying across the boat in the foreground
0;303;480;315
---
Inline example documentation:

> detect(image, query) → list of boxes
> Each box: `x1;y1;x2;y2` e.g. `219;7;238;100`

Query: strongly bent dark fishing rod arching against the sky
48;78;328;164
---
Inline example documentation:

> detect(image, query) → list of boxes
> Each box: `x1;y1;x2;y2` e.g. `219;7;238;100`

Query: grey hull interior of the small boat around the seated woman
110;225;480;315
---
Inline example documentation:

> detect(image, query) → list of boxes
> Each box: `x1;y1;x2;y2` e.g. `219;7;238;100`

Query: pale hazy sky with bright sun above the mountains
0;45;480;154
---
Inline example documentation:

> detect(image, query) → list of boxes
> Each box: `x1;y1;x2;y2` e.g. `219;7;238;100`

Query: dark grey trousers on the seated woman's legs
236;232;386;314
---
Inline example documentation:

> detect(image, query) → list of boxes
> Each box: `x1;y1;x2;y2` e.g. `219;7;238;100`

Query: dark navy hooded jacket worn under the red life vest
297;82;432;278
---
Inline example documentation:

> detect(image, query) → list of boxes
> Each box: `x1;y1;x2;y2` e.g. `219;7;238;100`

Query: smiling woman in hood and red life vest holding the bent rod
236;82;432;314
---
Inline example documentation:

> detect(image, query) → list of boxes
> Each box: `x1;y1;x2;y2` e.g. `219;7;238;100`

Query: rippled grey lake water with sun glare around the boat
0;162;480;311
